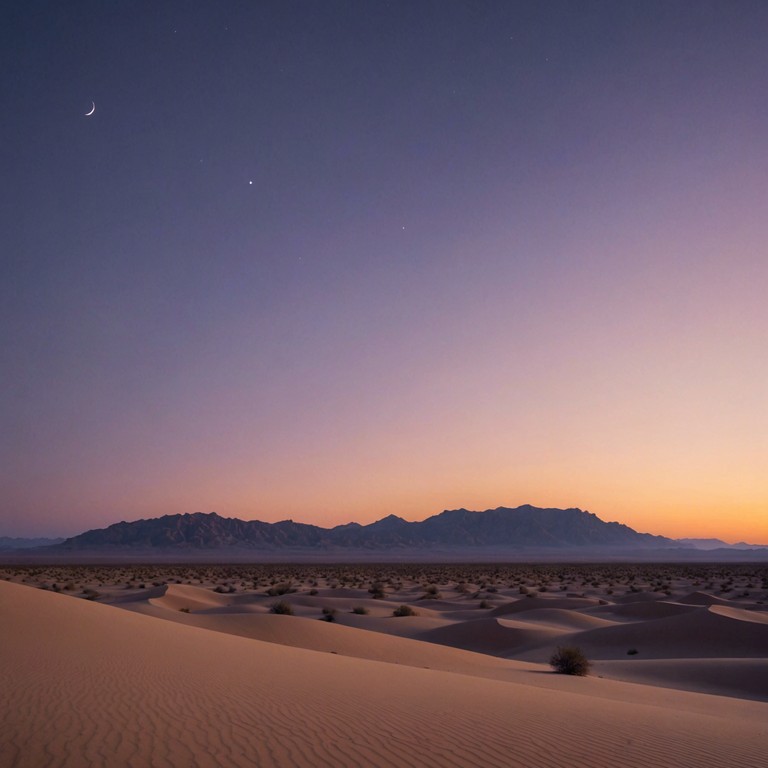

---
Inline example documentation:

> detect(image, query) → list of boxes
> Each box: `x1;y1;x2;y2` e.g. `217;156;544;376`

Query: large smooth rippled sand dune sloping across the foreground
0;583;768;768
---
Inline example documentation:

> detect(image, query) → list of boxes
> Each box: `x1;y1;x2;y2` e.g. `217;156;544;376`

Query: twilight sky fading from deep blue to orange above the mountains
0;0;768;543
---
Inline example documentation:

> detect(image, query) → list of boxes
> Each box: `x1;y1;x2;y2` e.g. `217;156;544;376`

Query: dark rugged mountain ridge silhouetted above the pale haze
52;504;680;551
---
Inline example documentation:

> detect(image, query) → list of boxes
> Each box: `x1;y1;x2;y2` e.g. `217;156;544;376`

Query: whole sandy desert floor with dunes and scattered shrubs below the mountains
0;564;768;768
